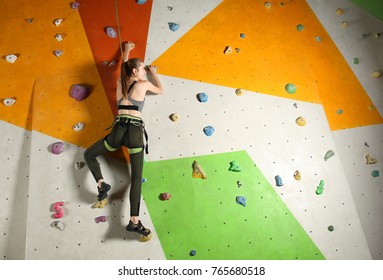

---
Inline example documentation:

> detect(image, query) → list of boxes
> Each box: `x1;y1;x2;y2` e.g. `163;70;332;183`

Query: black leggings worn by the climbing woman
84;115;144;216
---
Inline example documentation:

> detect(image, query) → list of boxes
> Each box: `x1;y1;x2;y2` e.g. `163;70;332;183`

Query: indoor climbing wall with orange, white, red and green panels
0;0;383;259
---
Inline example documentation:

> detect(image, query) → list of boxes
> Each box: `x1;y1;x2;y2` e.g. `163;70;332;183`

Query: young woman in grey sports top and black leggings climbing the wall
84;42;163;237
